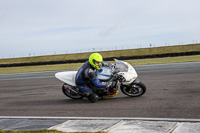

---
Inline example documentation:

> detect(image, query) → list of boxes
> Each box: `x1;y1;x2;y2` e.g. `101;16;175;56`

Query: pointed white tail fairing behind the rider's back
55;71;78;86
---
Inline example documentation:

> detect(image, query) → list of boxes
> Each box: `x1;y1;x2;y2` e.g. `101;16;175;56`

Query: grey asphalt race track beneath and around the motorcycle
0;62;200;119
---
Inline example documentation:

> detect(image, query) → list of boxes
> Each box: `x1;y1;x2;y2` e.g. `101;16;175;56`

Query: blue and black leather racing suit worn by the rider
76;61;108;94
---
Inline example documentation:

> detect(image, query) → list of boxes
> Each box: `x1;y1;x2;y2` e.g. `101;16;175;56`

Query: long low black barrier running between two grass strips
0;51;200;67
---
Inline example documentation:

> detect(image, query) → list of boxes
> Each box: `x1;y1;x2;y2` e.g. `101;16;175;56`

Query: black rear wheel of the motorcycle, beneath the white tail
62;84;83;99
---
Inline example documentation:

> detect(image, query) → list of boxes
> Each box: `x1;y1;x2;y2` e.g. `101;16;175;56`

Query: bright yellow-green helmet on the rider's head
89;53;103;70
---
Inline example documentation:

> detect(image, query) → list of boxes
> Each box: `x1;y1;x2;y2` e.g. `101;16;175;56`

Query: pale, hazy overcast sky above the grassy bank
0;0;200;58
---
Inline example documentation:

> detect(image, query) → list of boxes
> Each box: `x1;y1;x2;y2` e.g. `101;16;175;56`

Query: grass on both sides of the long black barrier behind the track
0;44;200;74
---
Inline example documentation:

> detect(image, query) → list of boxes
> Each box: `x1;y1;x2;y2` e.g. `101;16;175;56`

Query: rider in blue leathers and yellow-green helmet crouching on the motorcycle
76;53;112;102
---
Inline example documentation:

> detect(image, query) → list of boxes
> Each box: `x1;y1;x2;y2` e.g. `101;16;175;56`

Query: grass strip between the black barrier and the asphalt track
0;55;200;74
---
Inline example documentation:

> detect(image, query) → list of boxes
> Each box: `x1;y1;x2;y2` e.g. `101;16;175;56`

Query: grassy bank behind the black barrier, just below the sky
0;44;200;64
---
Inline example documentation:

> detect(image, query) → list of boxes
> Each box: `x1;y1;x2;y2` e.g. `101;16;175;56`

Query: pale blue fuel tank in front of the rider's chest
97;66;112;81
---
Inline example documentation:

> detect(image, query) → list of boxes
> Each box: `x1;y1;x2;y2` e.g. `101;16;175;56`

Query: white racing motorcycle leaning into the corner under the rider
55;59;146;99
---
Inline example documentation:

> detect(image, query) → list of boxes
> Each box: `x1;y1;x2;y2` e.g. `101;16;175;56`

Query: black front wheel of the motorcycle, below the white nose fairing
121;81;146;97
